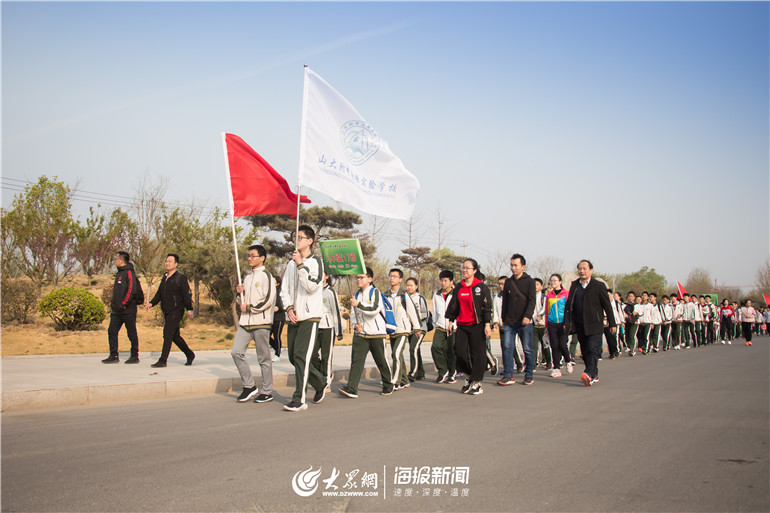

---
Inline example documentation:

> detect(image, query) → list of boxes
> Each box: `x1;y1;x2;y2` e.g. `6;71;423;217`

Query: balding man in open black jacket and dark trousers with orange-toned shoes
564;260;617;387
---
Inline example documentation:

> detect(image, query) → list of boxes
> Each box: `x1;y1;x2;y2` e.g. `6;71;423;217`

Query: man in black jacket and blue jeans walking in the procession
497;253;536;385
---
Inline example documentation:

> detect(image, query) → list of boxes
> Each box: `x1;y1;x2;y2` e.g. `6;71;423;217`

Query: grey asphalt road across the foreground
2;337;770;512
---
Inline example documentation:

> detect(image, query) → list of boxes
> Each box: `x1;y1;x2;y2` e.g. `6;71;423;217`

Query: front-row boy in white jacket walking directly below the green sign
338;267;393;399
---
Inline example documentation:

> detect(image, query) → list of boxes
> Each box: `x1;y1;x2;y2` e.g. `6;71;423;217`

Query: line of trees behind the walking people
0;176;770;324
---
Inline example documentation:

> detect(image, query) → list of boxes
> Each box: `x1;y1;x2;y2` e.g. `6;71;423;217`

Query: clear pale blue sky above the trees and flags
2;2;770;285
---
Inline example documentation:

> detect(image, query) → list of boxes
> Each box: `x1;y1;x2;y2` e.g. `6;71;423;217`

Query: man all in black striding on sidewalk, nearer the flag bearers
147;253;195;367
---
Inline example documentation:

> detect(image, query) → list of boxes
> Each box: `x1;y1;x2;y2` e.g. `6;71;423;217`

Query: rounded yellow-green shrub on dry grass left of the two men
40;287;107;331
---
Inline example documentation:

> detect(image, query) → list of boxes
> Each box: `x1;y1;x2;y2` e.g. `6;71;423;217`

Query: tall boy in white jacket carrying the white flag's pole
281;225;326;411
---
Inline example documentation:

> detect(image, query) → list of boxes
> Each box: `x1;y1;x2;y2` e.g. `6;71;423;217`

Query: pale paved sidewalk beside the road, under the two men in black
1;342;444;412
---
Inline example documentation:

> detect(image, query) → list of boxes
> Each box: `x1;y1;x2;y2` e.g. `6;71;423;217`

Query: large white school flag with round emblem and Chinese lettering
299;67;420;219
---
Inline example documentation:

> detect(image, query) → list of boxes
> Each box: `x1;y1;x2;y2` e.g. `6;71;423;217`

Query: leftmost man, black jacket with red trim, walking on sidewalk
102;251;144;363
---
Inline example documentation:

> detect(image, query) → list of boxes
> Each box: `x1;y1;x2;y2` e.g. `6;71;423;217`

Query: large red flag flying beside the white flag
225;134;310;217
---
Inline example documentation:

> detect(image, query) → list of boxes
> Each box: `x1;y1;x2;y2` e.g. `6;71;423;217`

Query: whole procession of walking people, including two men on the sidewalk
104;225;770;412
